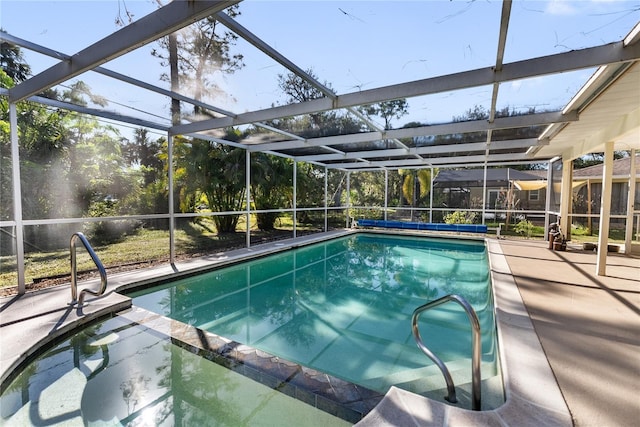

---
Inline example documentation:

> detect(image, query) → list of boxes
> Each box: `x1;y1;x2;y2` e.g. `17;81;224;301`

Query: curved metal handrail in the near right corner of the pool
411;294;481;411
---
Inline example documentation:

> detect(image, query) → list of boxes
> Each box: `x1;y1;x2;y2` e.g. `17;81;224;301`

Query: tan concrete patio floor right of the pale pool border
501;240;640;427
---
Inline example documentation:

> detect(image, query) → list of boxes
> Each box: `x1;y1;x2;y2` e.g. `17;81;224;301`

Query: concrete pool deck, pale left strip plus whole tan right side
0;233;640;426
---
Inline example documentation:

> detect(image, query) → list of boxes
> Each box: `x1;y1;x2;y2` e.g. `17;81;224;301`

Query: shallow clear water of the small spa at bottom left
0;317;350;426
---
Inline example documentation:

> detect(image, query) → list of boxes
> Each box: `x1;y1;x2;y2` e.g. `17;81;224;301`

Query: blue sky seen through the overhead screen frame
0;0;640;138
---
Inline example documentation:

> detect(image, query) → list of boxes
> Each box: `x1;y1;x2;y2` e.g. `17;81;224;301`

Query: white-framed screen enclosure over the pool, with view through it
0;0;640;293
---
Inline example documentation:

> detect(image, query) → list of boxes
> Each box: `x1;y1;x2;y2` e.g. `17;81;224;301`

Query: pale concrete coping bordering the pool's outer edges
0;229;573;427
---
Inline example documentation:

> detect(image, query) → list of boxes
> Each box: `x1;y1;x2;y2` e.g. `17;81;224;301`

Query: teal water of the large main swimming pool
129;233;502;408
